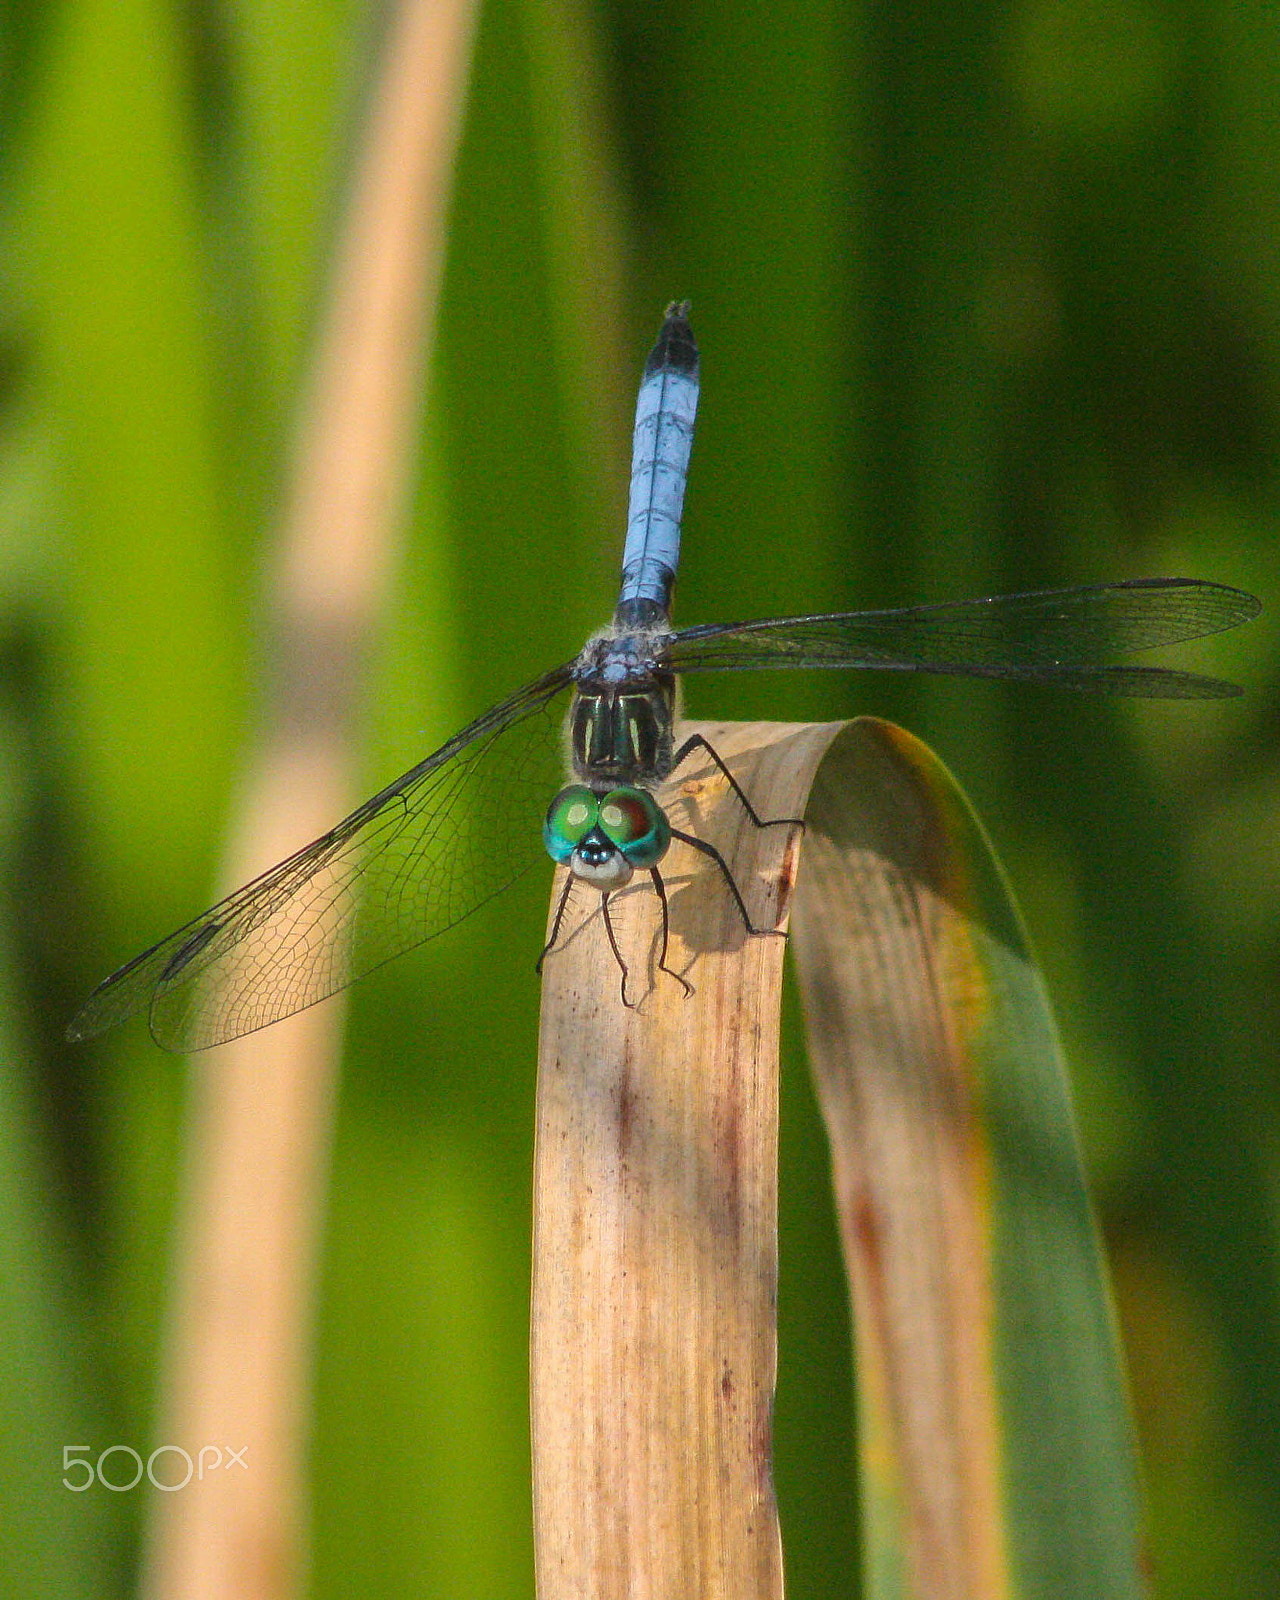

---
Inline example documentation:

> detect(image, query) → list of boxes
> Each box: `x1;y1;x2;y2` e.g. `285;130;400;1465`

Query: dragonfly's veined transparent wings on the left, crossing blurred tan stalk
67;666;570;1050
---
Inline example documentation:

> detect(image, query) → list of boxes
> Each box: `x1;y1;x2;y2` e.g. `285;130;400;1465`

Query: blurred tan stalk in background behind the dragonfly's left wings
142;0;475;1600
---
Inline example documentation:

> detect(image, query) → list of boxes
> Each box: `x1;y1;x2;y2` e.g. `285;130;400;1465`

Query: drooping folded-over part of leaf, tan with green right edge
794;718;1142;1600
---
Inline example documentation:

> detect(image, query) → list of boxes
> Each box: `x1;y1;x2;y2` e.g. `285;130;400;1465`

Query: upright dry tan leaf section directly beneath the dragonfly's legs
531;725;834;1600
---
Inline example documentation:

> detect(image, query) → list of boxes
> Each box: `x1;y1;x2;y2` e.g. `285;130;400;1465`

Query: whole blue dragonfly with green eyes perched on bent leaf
67;301;1261;1051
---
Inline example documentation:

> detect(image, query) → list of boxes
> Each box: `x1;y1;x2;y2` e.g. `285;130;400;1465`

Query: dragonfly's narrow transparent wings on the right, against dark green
662;578;1261;699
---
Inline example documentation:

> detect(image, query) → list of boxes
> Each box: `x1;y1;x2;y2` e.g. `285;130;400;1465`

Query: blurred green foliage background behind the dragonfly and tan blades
0;0;1280;1600
